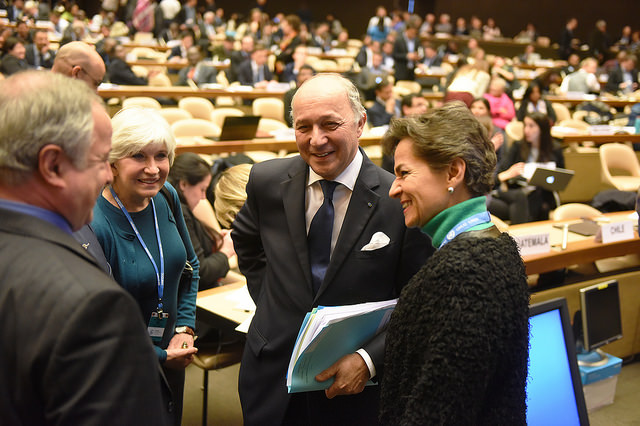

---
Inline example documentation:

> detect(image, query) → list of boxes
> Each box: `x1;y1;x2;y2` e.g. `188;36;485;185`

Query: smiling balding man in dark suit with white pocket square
231;74;431;426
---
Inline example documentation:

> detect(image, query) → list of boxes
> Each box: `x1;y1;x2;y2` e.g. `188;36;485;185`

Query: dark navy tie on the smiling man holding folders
307;180;338;294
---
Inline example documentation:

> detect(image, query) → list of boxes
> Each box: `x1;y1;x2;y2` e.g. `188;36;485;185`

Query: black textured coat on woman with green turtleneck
380;233;529;425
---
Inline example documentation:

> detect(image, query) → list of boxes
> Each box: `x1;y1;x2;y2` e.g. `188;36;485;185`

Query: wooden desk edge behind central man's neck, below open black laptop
176;136;380;154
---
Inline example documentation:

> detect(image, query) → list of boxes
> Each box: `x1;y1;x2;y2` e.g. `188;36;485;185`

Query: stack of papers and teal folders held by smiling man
287;299;397;393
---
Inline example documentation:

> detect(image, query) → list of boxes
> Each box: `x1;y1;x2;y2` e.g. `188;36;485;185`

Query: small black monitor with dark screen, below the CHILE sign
574;280;622;352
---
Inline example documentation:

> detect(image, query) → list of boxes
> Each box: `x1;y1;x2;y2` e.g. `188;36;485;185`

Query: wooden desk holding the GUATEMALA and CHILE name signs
509;212;640;275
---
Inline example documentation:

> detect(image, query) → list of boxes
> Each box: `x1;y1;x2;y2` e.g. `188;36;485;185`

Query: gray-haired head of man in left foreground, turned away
0;71;112;230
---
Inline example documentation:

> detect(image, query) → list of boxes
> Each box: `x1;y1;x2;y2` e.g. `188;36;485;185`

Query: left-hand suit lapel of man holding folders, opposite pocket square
281;158;312;290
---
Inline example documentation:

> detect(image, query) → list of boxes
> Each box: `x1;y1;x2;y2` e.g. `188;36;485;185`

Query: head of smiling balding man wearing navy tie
291;74;367;180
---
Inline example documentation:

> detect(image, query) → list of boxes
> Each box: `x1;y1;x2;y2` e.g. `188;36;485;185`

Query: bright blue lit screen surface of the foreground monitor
527;309;580;426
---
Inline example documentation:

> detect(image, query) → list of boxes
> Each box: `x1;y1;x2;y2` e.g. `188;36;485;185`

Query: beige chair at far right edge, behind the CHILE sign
600;143;640;192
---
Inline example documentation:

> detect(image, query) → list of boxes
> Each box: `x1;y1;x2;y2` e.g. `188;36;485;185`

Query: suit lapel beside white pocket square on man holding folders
316;152;380;298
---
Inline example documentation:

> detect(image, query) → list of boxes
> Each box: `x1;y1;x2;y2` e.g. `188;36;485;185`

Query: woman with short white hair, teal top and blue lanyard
92;107;199;424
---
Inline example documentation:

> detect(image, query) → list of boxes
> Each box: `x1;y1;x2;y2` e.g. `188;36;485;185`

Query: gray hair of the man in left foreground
0;71;102;184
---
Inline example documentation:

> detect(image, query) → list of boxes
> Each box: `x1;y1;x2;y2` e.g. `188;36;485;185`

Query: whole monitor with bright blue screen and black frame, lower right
527;298;589;426
